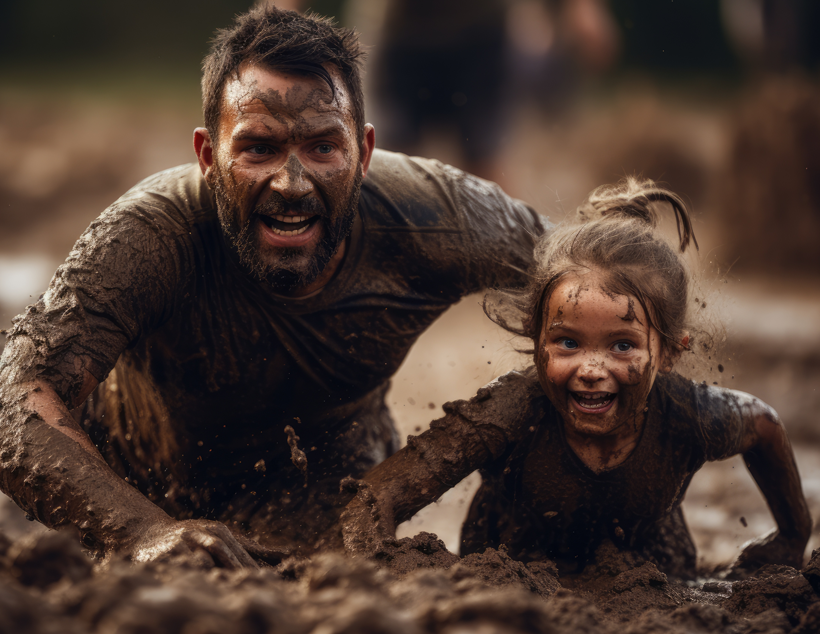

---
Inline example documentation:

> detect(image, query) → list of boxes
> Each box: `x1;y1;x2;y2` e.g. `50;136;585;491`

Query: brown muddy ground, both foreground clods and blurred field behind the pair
0;76;820;634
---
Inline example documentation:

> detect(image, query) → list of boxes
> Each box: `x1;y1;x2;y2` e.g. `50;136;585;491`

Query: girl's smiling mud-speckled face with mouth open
536;272;661;437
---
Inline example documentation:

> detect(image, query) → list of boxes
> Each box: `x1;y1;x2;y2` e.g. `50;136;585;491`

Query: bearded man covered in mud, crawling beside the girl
0;7;546;567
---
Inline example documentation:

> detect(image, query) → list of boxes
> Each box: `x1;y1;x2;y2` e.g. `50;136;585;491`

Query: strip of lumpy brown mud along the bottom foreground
0;532;820;634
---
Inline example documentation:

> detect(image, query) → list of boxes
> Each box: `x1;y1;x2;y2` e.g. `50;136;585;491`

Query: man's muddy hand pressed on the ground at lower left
126;519;259;570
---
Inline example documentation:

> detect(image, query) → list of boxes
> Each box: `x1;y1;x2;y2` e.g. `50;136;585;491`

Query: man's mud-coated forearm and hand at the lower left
0;340;256;568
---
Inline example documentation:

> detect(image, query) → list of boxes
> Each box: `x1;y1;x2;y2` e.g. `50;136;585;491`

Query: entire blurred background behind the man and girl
0;0;820;564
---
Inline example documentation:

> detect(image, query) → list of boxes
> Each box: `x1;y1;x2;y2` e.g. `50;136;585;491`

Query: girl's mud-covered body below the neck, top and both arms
343;368;810;575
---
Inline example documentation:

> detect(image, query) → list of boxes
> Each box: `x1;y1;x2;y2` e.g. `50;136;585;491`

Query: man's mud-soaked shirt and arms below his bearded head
0;152;547;550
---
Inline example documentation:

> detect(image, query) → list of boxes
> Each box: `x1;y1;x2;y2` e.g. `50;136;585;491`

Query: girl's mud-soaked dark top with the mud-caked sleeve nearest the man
350;367;747;561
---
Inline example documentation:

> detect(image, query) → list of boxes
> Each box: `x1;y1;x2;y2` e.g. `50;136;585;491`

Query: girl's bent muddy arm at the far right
733;392;811;570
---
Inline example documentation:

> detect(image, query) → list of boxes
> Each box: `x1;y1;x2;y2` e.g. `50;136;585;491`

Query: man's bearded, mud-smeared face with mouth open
206;66;363;291
